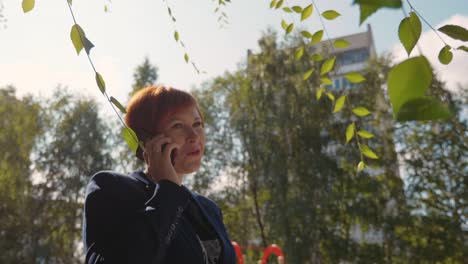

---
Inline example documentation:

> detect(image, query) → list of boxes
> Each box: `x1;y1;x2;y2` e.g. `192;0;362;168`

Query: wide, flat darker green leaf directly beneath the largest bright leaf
396;96;452;121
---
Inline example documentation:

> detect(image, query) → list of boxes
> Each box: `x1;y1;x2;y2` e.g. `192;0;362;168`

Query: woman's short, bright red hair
125;86;204;160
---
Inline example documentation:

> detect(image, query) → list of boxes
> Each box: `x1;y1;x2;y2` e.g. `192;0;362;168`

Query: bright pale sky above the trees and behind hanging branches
0;0;468;108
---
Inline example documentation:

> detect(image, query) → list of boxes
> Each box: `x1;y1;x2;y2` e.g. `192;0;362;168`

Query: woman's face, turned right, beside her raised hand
160;106;205;174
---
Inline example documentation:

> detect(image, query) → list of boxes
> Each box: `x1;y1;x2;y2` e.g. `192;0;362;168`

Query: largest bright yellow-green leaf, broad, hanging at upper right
388;56;432;118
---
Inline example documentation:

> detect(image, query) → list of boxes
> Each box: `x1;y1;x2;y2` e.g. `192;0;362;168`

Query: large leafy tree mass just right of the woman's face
194;33;405;263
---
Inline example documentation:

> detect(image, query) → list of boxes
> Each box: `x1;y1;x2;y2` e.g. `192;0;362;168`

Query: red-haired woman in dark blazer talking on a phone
83;86;236;264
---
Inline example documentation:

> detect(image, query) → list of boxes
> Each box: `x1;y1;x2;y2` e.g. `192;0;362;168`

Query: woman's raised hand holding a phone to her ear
143;134;182;186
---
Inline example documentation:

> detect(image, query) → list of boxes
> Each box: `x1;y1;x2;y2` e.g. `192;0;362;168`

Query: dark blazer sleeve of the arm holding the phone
83;173;190;264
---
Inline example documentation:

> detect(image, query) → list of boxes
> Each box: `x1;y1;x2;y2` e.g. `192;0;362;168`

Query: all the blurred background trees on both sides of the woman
0;29;468;263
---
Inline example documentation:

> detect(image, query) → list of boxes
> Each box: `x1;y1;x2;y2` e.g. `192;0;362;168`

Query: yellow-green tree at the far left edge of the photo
0;86;43;263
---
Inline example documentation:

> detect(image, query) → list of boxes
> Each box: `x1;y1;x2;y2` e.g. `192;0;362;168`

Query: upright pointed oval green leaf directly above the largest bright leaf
398;12;422;56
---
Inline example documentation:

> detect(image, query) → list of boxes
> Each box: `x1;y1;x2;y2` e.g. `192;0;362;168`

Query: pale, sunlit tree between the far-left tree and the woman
29;87;113;263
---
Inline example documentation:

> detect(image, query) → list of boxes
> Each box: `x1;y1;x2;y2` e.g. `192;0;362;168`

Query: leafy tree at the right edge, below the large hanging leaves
398;80;468;263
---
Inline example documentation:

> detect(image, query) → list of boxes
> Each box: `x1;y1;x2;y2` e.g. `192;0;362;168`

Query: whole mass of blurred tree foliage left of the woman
0;87;113;263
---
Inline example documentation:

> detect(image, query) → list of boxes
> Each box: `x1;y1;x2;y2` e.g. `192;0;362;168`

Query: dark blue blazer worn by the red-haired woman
83;171;237;264
